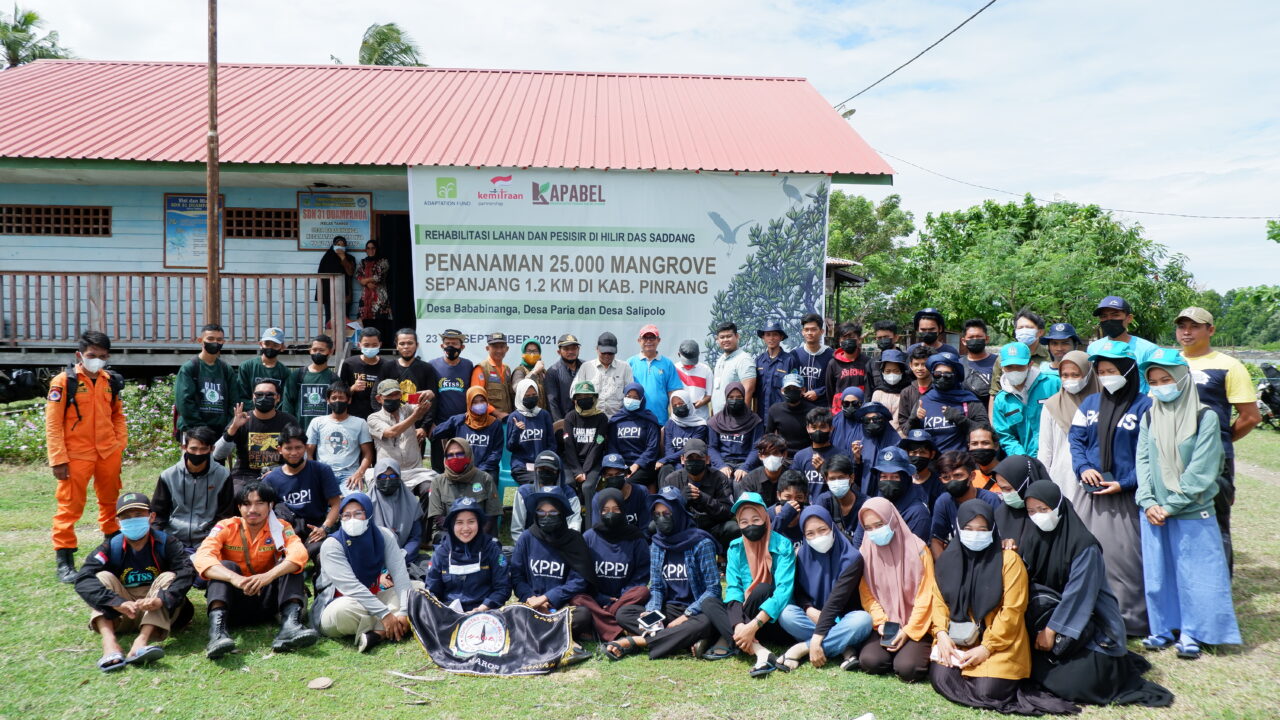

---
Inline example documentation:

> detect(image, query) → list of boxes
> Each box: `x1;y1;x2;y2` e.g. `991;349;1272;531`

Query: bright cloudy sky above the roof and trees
22;0;1280;291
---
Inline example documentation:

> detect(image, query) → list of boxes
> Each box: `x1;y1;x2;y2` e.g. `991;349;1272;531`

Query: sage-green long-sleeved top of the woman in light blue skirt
1137;407;1225;519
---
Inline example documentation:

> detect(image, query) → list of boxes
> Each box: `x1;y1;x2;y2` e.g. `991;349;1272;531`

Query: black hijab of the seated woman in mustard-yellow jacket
934;498;1005;623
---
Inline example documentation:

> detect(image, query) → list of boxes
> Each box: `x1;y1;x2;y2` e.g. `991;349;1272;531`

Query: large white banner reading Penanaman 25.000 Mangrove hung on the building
408;167;828;357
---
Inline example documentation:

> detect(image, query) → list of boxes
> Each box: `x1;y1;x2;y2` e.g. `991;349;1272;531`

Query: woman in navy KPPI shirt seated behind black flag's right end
511;492;596;653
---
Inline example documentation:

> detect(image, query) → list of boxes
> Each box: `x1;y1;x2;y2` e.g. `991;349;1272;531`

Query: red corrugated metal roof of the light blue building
0;60;893;176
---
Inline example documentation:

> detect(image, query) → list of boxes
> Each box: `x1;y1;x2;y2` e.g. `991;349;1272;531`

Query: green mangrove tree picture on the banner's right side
704;183;827;364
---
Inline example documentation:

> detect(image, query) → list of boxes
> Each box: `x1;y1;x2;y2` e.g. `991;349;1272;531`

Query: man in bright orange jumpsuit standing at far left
45;331;129;583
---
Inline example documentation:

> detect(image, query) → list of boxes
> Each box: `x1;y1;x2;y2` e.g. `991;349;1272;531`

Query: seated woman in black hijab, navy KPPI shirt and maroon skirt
571;488;649;643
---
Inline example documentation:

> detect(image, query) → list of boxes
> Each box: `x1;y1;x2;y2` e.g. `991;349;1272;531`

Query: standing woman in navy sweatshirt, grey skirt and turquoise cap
1068;340;1151;637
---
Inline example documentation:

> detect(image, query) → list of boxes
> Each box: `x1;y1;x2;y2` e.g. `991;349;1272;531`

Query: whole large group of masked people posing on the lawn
46;293;1257;714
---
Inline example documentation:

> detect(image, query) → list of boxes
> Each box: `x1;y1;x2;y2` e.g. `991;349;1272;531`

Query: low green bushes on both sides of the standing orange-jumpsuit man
0;375;182;464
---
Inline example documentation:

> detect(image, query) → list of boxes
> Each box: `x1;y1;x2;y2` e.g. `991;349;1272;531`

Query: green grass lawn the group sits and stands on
0;432;1280;720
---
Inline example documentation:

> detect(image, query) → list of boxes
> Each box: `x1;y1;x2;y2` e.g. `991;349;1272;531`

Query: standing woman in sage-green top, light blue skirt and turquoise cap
1137;347;1240;660
